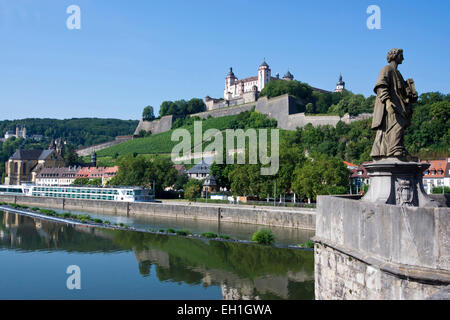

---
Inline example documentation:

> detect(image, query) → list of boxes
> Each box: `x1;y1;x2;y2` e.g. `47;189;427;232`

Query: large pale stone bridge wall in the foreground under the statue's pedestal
314;196;450;300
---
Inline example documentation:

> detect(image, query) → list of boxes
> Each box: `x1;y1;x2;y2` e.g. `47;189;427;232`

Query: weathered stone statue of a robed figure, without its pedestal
370;49;417;160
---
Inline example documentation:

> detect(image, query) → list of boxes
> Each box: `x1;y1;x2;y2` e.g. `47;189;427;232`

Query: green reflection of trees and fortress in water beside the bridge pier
114;231;314;299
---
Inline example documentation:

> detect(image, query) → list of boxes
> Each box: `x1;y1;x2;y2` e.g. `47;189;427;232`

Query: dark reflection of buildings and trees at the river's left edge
0;212;119;252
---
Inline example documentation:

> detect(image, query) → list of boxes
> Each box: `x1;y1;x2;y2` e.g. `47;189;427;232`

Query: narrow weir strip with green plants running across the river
0;202;313;251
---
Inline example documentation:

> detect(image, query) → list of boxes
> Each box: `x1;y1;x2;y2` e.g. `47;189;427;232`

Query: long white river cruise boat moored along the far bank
0;184;155;202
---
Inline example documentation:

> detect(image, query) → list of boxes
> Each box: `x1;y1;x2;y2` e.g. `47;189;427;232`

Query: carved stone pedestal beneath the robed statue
362;158;440;207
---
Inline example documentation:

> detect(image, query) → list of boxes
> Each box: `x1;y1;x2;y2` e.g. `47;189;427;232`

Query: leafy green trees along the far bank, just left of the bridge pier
211;140;349;202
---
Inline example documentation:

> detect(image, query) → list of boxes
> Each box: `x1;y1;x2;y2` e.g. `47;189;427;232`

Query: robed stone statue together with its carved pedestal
362;49;440;207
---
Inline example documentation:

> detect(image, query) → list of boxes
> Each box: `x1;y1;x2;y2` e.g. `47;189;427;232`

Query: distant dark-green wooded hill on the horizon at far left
0;118;138;148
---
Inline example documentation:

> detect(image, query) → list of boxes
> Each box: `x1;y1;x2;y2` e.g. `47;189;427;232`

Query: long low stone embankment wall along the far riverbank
0;195;316;230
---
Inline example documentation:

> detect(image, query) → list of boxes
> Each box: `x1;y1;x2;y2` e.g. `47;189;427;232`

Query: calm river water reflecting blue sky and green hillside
0;211;314;300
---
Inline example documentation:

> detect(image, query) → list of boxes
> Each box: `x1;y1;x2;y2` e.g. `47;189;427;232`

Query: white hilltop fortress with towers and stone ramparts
134;60;372;135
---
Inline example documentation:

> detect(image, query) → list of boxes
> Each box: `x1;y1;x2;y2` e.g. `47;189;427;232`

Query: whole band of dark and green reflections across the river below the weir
0;213;314;299
